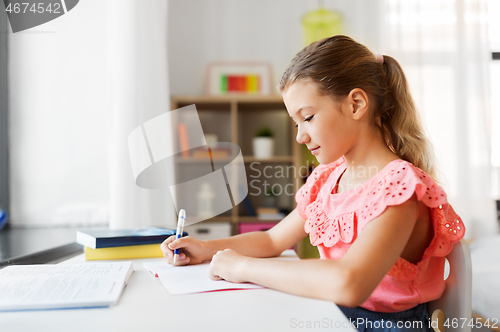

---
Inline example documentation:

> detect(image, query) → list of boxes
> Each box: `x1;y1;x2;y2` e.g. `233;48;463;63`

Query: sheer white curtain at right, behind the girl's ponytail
380;0;497;238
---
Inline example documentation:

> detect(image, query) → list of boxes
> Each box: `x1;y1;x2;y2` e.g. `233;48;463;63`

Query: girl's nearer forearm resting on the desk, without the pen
239;258;364;307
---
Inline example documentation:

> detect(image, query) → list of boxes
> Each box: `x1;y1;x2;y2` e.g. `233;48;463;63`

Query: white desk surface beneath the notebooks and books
0;255;355;332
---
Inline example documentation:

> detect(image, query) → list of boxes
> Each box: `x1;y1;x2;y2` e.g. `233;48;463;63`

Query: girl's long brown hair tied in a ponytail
277;35;437;179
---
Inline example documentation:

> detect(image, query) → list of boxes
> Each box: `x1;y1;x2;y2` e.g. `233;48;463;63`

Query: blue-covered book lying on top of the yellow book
76;227;187;249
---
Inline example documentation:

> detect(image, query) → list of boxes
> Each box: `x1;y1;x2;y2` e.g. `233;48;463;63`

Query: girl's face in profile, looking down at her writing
283;81;360;164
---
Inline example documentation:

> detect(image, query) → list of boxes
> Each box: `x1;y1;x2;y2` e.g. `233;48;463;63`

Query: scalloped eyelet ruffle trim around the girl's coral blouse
296;160;465;280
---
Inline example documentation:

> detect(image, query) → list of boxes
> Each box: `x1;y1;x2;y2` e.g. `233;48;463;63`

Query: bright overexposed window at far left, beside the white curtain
9;0;109;226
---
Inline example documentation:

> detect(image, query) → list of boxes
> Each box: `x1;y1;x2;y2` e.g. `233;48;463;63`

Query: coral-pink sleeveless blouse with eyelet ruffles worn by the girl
295;157;465;312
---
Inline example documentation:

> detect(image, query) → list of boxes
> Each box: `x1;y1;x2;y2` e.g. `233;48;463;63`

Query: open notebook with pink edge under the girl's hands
143;250;298;295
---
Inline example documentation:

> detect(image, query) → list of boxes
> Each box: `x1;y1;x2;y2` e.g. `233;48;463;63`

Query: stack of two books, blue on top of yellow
76;227;187;260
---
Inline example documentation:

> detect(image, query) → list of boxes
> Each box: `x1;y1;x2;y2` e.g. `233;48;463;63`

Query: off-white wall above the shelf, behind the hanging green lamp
168;0;379;95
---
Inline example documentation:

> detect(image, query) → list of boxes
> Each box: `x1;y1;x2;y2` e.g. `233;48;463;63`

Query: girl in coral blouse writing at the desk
161;36;465;331
